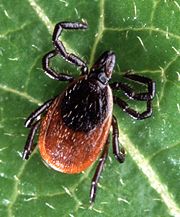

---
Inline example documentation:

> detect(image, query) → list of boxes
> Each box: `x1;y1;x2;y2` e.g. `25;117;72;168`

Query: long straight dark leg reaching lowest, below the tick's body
90;137;109;205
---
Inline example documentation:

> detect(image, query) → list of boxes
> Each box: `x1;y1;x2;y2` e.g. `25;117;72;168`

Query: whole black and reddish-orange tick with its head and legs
22;22;155;203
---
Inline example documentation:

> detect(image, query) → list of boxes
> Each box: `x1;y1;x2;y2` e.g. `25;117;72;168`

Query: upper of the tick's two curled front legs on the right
110;74;155;101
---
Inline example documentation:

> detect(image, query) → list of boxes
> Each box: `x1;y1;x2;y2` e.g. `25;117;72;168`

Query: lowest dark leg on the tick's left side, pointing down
22;121;39;160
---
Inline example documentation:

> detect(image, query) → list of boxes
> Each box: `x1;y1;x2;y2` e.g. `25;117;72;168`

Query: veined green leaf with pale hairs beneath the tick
0;0;180;217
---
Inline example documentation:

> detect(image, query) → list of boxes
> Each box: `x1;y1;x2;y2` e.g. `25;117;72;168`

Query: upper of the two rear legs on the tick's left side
24;99;54;128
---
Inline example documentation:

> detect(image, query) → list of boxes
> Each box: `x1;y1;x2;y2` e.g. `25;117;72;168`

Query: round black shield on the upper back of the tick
60;79;108;132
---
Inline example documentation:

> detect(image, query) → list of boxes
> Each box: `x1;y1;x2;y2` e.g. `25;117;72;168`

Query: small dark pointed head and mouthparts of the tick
89;51;115;84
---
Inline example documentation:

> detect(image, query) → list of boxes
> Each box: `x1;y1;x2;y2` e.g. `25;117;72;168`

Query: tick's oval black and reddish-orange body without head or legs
38;76;113;173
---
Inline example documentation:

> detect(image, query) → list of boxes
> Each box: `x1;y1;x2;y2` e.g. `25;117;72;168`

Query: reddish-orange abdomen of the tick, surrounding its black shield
38;79;112;173
